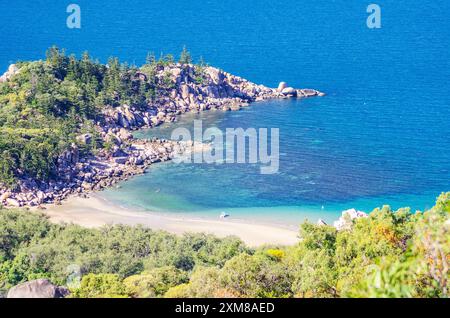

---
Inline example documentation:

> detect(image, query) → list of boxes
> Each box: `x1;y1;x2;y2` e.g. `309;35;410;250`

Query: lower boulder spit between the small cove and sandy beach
0;138;195;208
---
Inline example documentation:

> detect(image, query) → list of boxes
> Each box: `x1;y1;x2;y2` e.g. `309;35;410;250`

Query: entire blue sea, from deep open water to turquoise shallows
0;0;450;222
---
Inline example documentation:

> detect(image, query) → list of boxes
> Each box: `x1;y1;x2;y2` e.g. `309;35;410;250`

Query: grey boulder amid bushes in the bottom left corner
6;279;69;298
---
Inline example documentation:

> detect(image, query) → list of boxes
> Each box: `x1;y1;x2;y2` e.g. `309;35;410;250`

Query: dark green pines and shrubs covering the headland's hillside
0;47;203;187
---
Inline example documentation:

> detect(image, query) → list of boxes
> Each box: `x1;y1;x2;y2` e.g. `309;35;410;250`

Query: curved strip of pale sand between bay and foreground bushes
38;195;298;247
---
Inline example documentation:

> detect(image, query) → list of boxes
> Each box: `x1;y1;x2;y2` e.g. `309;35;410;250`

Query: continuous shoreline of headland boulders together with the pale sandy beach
0;62;324;246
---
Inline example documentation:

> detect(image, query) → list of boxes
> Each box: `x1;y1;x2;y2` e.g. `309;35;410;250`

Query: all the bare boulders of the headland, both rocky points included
0;63;324;208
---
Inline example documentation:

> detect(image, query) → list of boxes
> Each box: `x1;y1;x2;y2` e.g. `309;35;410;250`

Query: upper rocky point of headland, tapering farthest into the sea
97;64;324;129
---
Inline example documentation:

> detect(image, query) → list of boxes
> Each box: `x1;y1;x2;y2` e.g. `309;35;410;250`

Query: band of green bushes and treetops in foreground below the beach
0;192;450;297
